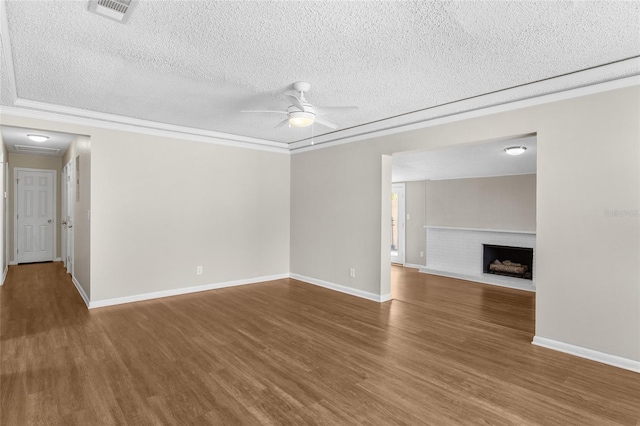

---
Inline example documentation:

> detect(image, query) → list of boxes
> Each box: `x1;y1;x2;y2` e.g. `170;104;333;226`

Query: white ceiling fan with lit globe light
240;81;358;129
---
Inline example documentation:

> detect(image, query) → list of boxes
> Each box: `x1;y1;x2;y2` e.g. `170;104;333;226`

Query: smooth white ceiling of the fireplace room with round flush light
392;136;537;182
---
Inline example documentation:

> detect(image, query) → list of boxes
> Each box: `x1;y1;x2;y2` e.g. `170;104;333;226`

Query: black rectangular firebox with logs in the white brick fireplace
482;244;533;280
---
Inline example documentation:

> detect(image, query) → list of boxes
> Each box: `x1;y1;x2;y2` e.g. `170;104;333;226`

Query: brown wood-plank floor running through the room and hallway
0;263;640;426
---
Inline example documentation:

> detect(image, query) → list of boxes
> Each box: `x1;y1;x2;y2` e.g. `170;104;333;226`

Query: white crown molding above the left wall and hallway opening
0;103;289;154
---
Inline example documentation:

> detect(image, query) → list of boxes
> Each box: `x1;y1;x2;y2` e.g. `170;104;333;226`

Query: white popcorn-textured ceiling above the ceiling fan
0;0;640;143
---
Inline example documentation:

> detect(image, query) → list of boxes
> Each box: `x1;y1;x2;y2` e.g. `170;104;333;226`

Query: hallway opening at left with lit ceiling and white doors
0;125;90;286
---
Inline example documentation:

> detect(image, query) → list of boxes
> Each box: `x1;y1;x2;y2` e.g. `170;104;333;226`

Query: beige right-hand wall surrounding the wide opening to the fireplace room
291;86;640;361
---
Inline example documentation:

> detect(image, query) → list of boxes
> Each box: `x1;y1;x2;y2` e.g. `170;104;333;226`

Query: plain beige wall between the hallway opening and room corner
91;131;290;301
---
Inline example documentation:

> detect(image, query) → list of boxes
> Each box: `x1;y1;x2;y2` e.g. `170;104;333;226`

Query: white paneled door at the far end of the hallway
15;168;56;263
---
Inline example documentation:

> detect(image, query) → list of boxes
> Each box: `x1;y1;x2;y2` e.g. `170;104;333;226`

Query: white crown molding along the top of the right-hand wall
289;71;640;153
